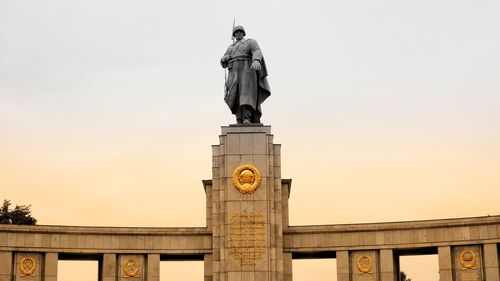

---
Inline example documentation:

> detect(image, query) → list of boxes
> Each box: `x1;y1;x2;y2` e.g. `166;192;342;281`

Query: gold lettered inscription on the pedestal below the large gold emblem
229;212;266;265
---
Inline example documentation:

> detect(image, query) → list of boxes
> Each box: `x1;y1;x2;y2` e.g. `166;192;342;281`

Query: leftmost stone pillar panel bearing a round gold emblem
14;252;44;281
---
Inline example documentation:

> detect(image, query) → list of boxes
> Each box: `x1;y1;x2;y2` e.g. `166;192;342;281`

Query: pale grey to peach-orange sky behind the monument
0;0;500;281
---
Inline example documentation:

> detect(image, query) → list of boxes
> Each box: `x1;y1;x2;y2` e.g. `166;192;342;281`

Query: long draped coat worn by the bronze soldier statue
221;39;271;121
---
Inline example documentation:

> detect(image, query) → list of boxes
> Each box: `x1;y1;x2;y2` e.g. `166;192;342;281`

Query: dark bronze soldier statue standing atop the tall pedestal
220;25;271;124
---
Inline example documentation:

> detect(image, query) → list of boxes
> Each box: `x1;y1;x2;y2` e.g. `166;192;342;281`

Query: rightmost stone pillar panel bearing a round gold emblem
451;245;489;281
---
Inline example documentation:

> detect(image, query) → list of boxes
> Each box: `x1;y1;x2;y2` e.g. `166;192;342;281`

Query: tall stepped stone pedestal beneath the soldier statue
208;125;283;281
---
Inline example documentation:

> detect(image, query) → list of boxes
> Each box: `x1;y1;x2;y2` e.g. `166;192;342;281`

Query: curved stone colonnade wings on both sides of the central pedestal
0;216;500;281
